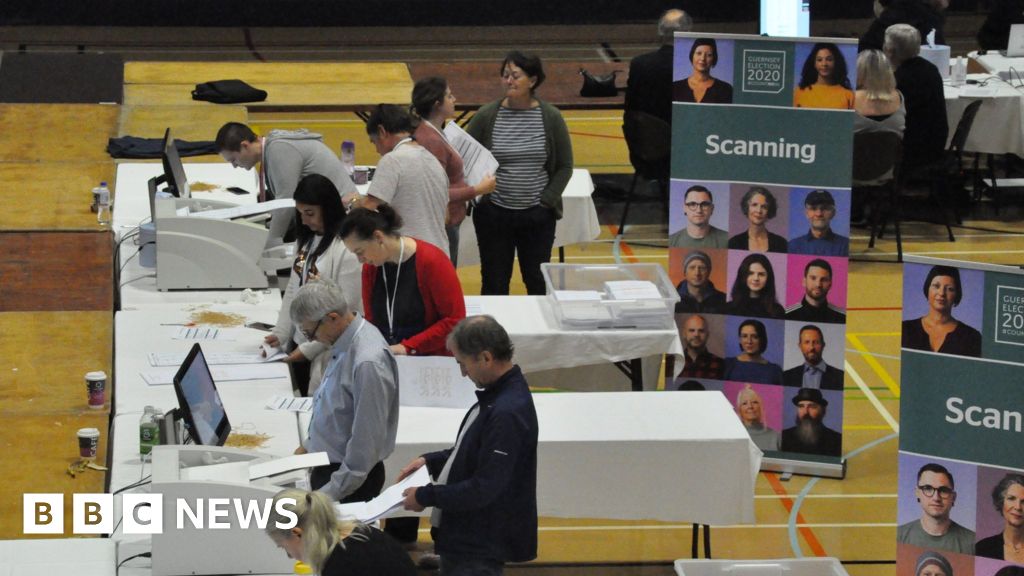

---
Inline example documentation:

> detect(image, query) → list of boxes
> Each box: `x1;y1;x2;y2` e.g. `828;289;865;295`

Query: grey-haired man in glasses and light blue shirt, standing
289;280;398;502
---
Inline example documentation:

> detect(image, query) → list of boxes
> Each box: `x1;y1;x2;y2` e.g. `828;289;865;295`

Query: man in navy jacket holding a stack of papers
399;316;538;576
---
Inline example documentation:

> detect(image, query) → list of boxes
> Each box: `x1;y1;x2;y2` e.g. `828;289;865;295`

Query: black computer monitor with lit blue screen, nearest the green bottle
174;342;231;446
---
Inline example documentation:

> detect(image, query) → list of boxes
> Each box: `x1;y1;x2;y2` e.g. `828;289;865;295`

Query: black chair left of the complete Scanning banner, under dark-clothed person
617;110;672;237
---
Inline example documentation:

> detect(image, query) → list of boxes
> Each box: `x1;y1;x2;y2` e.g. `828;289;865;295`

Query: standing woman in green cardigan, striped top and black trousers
466;51;572;295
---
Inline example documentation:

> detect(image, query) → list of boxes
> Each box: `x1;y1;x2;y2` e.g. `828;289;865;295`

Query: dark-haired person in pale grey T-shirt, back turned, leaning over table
344;105;449;256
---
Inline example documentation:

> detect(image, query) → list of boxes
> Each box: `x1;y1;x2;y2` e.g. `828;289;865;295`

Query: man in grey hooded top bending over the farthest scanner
216;122;355;246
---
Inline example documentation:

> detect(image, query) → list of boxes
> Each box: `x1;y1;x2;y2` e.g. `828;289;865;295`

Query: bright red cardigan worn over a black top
362;239;466;356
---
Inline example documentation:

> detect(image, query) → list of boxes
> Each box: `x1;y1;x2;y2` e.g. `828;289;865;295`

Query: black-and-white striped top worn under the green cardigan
490;107;548;210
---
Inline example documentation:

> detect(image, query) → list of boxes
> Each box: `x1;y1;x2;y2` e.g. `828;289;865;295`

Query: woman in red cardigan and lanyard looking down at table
339;203;466;356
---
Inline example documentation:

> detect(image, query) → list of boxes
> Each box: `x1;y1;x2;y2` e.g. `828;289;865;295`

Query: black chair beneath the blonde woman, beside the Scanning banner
852;131;903;261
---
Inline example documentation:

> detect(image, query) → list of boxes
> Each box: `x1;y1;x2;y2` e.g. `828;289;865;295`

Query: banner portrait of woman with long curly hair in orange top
793;42;853;110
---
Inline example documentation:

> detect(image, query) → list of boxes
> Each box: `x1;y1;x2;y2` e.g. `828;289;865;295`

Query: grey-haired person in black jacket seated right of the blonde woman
884;24;949;170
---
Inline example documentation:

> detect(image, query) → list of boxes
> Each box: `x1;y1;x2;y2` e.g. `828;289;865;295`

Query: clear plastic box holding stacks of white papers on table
541;263;679;330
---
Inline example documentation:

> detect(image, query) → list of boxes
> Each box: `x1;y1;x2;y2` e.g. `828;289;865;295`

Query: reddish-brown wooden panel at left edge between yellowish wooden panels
0;231;114;312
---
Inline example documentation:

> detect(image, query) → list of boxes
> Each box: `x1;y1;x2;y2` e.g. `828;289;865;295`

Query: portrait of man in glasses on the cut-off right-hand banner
896;462;974;554
